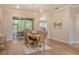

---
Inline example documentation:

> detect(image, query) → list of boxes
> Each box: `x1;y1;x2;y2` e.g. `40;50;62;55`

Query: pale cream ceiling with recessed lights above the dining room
0;4;79;12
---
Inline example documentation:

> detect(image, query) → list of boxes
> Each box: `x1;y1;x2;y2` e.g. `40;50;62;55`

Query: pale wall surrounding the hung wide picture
49;8;70;43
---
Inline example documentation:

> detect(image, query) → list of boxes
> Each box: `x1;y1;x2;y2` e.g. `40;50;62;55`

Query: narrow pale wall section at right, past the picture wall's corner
69;7;76;45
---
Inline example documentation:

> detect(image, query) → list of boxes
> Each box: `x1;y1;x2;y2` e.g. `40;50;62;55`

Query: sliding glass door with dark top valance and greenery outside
12;18;33;39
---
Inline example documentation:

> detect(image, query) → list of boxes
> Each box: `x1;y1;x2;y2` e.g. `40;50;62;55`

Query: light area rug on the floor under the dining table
22;44;51;55
